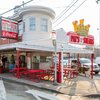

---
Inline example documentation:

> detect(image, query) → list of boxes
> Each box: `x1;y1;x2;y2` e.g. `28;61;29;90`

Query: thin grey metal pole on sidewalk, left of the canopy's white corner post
52;30;58;85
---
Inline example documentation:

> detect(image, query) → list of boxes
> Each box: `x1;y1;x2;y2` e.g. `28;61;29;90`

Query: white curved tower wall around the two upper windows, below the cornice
23;13;52;41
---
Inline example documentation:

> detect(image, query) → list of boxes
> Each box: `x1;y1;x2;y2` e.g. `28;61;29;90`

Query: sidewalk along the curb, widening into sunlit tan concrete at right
0;74;100;96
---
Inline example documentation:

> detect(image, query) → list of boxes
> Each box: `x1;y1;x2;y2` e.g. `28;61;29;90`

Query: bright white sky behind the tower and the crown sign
0;0;100;45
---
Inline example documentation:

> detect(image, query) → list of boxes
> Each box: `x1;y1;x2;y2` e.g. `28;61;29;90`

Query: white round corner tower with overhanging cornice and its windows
12;6;55;42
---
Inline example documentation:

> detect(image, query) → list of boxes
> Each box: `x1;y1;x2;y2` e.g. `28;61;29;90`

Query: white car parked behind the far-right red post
80;58;100;74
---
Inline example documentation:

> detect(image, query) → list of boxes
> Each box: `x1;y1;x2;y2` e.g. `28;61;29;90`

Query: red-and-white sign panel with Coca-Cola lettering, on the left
1;18;18;39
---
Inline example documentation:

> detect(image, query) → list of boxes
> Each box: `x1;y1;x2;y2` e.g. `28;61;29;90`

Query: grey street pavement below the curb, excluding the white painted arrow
1;77;100;100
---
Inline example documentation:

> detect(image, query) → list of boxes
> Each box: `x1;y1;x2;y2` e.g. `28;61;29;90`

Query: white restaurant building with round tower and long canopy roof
0;6;93;82
